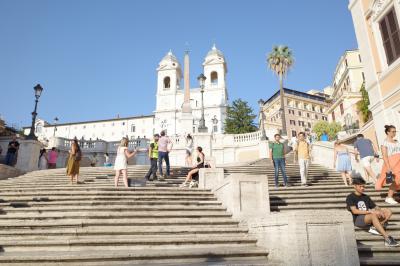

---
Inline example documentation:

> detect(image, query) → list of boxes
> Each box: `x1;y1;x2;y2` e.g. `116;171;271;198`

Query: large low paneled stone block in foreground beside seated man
247;210;360;266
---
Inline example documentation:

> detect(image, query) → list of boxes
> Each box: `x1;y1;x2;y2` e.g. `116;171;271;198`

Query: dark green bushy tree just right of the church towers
225;98;257;134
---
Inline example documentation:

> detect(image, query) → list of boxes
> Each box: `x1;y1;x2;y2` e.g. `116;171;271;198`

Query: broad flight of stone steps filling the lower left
0;166;274;265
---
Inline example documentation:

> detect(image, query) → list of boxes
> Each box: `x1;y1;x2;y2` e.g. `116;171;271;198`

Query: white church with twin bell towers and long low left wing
24;45;228;141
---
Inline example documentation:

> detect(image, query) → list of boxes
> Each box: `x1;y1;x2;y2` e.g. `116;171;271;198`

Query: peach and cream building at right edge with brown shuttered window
349;0;400;143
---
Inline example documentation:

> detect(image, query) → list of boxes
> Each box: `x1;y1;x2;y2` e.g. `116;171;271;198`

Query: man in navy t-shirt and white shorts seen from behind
354;134;379;183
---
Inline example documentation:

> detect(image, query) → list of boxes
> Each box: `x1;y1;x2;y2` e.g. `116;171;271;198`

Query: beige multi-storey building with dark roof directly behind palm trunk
262;88;328;137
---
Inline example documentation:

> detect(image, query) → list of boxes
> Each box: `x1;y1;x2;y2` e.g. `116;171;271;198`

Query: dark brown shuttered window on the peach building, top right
379;8;400;65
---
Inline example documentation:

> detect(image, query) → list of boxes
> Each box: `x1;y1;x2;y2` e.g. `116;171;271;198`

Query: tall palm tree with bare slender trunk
267;45;294;135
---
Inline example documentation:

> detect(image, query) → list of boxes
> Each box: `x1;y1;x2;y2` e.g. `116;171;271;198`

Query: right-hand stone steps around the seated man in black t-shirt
225;160;400;265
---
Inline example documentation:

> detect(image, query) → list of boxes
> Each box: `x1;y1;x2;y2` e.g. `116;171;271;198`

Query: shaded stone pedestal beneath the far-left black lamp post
15;140;43;172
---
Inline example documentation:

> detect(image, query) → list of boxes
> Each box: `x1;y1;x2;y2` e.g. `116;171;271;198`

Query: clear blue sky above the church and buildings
0;0;357;129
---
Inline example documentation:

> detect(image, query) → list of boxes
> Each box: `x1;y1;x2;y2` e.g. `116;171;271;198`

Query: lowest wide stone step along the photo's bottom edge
0;245;268;265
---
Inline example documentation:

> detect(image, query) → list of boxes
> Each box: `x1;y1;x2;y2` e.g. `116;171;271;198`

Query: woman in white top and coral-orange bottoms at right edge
375;126;400;204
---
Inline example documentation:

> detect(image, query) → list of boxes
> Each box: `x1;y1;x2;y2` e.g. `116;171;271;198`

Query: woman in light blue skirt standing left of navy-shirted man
333;140;352;186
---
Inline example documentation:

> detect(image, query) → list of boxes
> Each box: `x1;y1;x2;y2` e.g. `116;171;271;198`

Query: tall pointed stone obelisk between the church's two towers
179;51;193;135
